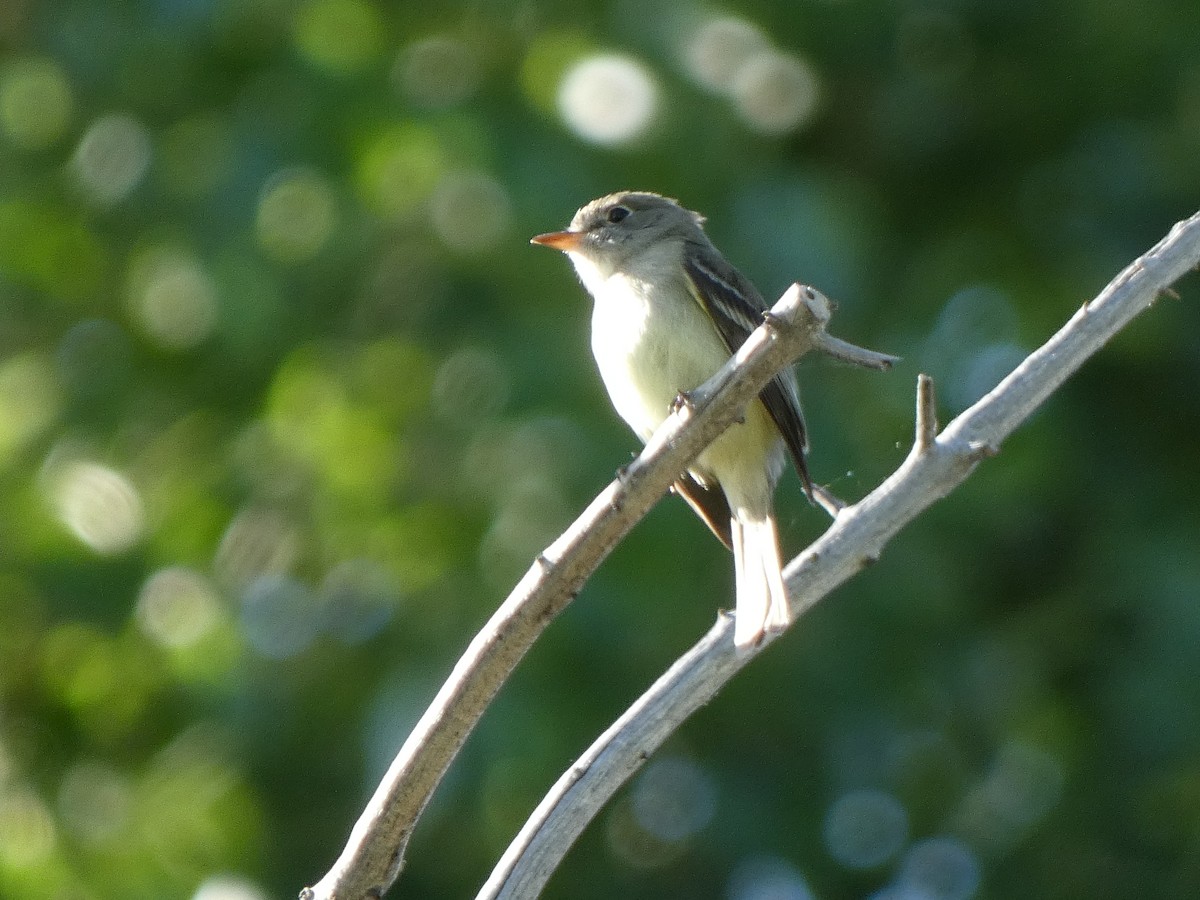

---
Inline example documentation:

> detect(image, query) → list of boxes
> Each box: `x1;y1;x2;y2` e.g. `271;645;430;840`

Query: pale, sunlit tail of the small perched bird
732;509;792;649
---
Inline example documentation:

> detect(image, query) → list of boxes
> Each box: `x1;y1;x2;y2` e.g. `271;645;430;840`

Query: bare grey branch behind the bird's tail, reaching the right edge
476;206;1200;900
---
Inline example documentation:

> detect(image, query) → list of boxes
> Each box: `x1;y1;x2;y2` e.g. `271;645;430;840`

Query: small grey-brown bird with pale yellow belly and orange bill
532;191;814;650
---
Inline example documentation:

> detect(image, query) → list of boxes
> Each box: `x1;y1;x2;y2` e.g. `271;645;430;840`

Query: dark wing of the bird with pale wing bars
684;242;812;500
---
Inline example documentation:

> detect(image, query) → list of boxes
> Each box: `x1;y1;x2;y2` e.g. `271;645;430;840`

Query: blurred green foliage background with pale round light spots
0;0;1200;900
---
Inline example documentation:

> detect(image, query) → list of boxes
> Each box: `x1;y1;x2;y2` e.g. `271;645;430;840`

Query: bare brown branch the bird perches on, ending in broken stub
300;284;894;900
